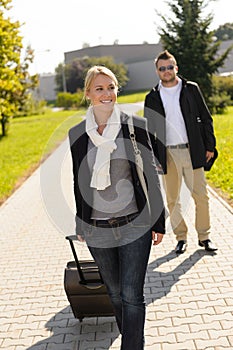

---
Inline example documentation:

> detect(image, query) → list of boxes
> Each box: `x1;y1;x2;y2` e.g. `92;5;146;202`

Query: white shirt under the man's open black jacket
159;78;188;146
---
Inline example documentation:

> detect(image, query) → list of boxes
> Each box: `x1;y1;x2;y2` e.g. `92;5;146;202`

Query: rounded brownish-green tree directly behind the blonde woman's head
55;56;128;93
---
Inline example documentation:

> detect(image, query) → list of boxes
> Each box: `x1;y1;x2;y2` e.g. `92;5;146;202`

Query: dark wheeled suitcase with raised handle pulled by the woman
64;236;114;321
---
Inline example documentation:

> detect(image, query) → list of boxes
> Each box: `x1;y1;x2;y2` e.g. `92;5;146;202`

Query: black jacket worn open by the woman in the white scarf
69;112;165;234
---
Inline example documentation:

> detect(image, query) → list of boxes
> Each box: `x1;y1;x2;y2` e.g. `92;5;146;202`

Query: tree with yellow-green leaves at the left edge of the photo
0;0;36;136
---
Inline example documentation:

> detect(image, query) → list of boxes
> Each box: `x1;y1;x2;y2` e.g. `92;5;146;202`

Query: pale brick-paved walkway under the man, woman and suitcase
0;104;233;350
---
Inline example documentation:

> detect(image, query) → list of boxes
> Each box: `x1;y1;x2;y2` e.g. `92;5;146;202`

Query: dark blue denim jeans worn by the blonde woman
89;231;151;350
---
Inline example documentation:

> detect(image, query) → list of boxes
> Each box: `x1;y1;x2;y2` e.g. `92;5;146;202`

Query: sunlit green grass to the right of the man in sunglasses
206;107;233;205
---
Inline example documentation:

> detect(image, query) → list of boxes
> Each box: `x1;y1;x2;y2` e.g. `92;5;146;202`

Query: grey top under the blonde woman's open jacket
87;130;138;220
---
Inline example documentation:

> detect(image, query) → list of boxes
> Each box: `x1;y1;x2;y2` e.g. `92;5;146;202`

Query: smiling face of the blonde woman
86;74;118;110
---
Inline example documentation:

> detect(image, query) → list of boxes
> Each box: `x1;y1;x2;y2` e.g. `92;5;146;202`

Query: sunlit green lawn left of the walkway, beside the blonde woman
0;110;85;203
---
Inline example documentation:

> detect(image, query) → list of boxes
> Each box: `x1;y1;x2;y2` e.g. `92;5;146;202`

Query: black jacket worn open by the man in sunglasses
144;77;216;174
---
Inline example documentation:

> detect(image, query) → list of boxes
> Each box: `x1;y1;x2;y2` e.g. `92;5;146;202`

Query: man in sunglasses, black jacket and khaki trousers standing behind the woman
144;50;217;254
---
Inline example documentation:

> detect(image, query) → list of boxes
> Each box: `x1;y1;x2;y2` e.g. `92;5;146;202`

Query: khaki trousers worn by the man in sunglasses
163;148;210;241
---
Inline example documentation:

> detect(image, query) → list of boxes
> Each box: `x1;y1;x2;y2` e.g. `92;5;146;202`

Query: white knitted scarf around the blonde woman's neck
86;105;121;190
